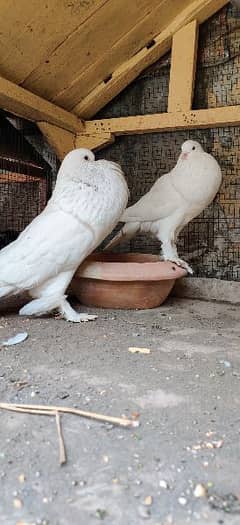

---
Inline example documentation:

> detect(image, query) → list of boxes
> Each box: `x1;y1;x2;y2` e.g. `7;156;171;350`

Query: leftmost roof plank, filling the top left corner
0;0;107;84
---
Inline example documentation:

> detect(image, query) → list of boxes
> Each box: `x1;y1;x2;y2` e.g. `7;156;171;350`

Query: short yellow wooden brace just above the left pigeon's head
37;122;76;160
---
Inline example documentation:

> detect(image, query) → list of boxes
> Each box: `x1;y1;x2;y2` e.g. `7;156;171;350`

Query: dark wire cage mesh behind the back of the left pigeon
0;113;52;249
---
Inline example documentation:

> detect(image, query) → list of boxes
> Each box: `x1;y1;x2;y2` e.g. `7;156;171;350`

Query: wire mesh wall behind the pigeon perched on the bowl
96;4;240;281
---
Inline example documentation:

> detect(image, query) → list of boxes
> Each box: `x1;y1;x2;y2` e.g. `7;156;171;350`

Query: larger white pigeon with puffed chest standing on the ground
0;149;129;322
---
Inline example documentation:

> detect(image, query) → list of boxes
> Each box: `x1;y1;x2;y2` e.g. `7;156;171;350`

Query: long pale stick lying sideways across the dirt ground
0;403;139;427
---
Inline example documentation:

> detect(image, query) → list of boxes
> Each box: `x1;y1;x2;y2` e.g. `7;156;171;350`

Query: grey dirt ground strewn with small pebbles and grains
0;299;240;525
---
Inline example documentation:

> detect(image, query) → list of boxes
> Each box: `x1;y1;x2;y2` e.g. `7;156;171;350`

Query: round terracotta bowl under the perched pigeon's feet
71;252;187;310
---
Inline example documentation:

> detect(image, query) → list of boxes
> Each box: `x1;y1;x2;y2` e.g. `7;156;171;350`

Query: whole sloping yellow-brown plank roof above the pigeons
0;0;227;118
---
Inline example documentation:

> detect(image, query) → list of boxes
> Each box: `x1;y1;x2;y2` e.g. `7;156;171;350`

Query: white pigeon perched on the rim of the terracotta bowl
105;140;222;273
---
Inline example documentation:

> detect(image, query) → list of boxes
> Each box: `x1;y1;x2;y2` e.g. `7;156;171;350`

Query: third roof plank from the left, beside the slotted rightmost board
53;0;189;110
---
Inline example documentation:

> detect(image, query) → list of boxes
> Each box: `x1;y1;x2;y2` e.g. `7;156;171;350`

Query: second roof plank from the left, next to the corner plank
23;0;159;100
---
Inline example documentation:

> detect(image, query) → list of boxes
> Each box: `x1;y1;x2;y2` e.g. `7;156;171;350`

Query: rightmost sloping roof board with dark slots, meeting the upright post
73;0;228;118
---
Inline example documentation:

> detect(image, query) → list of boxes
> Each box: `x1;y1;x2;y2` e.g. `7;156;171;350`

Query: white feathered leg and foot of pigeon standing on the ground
19;272;97;323
